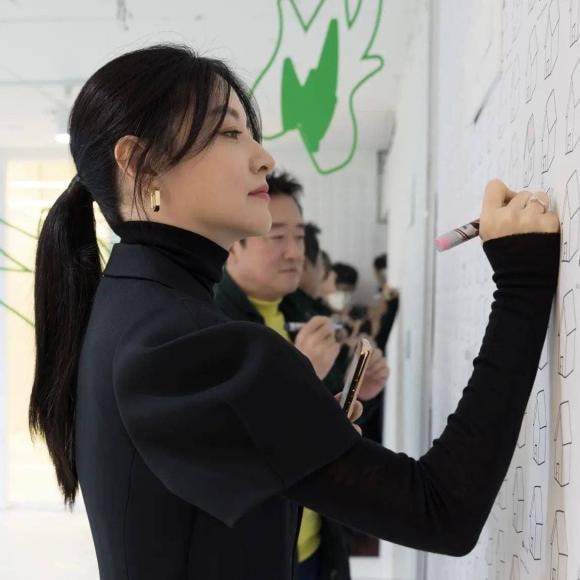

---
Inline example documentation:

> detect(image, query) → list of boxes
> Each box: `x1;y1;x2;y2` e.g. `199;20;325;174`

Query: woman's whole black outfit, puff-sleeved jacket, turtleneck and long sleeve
75;224;560;580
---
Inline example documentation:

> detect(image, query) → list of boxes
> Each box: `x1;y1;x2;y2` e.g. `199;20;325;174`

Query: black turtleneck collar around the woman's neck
115;221;228;292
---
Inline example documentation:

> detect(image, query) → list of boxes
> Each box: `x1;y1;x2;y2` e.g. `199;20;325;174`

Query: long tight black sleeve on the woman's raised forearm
287;234;559;556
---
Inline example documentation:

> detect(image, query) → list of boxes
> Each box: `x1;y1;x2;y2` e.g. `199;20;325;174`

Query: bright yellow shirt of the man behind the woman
248;297;321;562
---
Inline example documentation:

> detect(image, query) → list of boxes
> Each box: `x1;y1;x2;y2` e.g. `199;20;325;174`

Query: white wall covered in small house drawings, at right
428;0;580;580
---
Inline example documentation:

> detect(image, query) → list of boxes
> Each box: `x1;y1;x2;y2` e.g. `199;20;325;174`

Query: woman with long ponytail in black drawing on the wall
30;46;559;580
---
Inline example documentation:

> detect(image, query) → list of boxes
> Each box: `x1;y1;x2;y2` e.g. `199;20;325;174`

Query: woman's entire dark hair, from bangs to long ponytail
29;45;261;505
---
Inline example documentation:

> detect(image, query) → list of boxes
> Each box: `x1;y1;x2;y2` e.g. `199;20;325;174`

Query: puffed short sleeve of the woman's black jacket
113;320;359;526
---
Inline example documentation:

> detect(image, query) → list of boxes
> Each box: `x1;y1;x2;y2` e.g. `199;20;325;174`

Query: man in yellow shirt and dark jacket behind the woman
215;172;388;580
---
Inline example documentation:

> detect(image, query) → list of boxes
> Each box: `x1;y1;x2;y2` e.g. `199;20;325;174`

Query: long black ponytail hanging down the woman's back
29;178;101;505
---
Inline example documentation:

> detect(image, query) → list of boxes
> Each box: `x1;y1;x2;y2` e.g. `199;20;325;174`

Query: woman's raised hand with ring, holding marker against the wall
479;179;560;242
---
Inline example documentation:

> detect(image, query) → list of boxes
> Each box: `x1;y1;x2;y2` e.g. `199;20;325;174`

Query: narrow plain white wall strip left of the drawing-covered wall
376;1;430;579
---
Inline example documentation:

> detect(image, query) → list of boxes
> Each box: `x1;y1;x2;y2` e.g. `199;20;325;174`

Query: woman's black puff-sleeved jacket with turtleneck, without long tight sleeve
76;220;359;580
